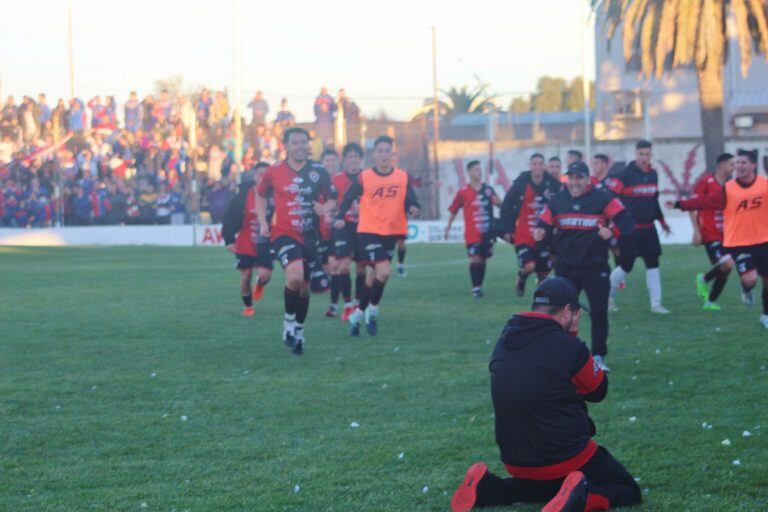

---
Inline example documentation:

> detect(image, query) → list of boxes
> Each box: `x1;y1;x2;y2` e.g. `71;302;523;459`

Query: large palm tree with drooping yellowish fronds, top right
591;0;768;169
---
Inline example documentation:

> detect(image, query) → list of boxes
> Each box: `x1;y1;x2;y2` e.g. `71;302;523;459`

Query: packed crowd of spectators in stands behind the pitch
0;87;360;227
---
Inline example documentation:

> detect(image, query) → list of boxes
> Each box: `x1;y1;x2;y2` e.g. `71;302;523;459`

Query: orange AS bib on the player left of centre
357;169;408;235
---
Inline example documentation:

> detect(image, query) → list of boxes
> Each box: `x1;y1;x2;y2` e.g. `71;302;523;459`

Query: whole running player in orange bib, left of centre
336;135;419;336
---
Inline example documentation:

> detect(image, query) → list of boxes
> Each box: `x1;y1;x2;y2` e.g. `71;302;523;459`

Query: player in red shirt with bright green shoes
680;153;734;311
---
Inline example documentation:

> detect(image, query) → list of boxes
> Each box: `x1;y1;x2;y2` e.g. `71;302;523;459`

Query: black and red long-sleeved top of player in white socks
604;161;664;228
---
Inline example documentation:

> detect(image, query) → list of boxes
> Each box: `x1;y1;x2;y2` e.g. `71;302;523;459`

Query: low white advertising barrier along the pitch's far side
0;218;693;247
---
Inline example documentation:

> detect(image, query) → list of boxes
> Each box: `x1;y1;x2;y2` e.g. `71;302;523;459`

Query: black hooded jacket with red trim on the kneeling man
489;313;608;480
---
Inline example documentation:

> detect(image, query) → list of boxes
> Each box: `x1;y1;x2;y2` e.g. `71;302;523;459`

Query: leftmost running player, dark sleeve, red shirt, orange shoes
221;162;272;316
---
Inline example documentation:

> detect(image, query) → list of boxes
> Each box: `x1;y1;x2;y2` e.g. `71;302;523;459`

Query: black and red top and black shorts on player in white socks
604;161;666;272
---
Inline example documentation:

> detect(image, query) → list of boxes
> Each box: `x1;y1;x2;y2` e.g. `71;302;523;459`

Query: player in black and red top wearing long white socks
606;140;671;315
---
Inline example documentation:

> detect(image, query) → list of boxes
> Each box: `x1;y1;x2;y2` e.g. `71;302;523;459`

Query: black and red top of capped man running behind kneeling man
539;187;635;267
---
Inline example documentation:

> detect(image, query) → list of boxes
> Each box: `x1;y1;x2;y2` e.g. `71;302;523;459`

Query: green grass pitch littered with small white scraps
0;245;768;512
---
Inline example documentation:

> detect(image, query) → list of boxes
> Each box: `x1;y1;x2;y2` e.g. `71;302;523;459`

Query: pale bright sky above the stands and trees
0;0;592;121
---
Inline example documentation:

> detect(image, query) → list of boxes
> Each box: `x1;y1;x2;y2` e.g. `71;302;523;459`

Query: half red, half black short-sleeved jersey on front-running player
256;161;336;242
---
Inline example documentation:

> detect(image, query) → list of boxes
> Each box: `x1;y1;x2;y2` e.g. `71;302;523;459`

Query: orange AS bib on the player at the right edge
723;176;768;247
